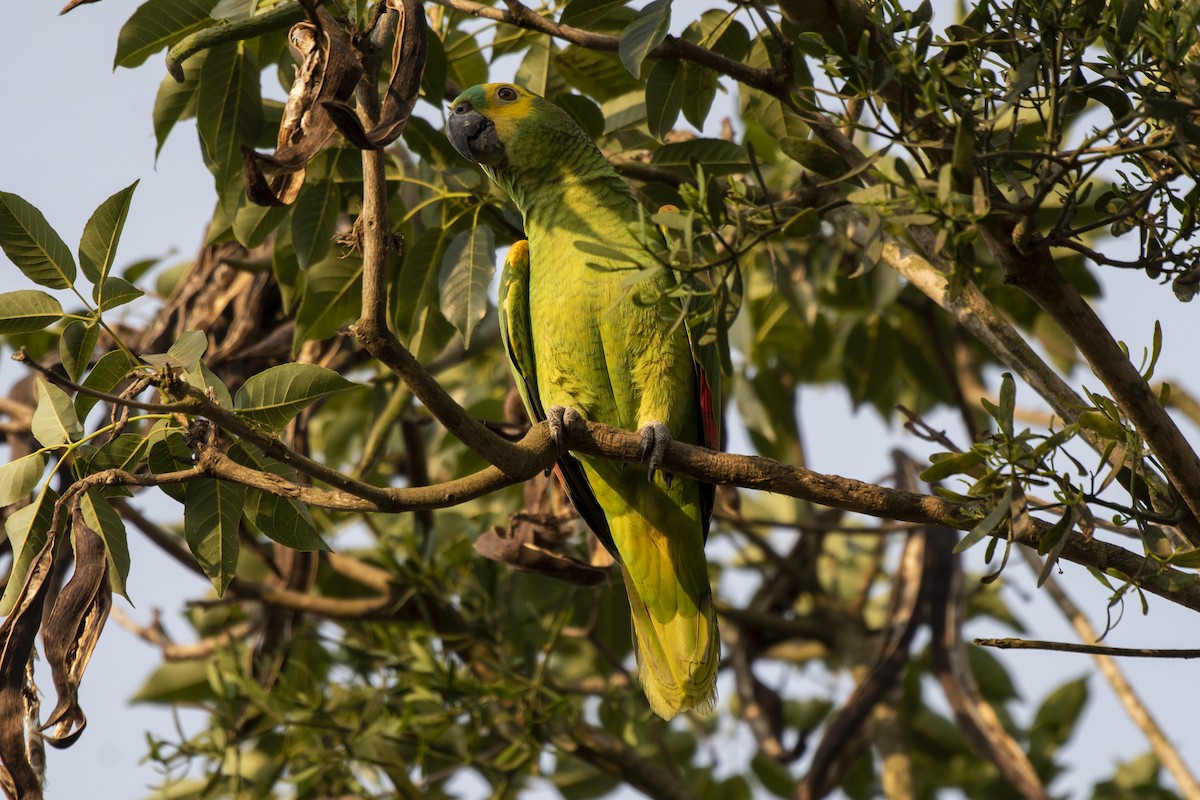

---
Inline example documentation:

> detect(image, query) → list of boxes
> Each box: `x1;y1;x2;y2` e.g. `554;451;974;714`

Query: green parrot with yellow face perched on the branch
446;83;720;720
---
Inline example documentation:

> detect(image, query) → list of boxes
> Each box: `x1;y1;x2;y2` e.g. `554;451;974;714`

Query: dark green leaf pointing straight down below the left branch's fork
184;477;244;596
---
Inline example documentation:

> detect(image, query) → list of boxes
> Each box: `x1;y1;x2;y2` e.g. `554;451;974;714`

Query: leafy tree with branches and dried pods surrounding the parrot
0;0;1200;799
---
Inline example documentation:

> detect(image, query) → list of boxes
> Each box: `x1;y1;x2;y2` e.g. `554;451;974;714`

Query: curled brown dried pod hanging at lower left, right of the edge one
42;505;113;748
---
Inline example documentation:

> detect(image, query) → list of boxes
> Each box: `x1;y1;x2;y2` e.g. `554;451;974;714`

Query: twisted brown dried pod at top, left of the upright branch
241;6;362;205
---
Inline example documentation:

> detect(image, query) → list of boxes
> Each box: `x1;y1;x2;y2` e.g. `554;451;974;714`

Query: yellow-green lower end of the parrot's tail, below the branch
622;560;721;720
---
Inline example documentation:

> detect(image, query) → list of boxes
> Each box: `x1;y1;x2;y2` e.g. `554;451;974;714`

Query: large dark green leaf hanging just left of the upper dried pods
196;43;263;217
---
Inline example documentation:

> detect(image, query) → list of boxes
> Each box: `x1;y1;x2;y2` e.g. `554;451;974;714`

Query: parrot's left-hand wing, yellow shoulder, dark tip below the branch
498;239;614;560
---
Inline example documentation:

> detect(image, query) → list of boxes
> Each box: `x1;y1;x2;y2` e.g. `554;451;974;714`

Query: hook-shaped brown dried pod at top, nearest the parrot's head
325;0;428;150
